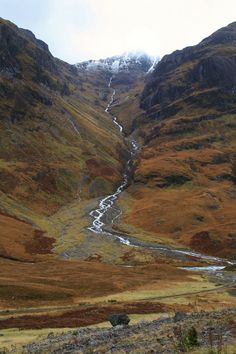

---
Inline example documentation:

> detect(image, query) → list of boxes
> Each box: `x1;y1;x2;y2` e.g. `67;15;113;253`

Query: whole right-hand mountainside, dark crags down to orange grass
117;23;236;257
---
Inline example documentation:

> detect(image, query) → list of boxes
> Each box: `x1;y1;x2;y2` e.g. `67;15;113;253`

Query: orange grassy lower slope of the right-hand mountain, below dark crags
117;127;236;256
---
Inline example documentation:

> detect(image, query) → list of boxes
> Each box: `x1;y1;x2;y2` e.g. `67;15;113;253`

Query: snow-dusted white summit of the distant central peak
76;52;157;74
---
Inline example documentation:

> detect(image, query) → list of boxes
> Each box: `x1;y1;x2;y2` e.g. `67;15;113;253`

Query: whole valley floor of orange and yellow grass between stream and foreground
0;209;234;328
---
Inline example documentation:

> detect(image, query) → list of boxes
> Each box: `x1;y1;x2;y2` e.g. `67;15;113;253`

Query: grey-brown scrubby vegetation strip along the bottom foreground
2;309;236;354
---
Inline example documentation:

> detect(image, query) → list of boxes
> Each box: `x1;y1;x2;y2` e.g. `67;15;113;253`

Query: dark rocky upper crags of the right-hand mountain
141;22;236;115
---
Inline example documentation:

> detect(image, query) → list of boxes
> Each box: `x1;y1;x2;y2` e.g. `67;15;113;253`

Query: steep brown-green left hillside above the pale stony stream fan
0;20;126;218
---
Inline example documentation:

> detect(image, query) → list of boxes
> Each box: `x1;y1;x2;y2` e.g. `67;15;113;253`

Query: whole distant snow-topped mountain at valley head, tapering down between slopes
76;52;155;135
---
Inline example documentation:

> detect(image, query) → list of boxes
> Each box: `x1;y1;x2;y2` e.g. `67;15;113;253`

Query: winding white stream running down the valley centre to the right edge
88;76;236;283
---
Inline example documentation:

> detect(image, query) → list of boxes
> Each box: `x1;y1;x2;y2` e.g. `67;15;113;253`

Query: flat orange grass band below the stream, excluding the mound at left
0;253;192;308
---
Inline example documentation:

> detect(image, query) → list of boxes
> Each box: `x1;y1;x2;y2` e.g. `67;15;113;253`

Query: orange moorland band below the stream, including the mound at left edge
0;213;195;308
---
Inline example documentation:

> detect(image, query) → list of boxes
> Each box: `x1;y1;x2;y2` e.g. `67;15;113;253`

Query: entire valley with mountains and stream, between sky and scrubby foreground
0;15;236;352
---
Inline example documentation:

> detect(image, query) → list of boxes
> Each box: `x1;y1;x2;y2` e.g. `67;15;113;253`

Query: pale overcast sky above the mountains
0;0;236;63
